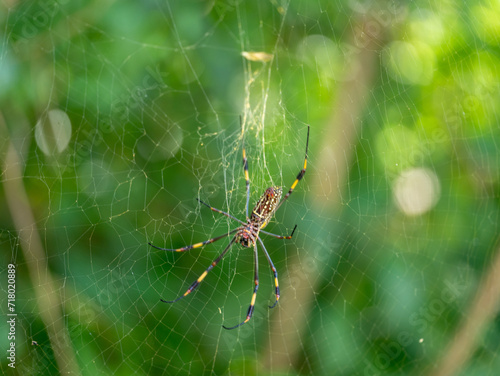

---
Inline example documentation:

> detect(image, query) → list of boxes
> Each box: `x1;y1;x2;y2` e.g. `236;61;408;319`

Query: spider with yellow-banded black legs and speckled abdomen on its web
148;125;310;330
